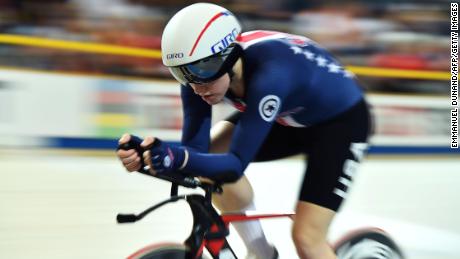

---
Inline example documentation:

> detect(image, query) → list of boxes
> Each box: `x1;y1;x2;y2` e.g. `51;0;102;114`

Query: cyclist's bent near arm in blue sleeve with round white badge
183;62;292;181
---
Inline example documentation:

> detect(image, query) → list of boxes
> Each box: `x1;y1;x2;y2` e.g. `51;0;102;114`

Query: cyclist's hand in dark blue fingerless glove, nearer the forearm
141;137;186;175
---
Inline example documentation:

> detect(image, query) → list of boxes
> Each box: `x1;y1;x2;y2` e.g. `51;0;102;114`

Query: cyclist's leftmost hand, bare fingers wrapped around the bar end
117;134;143;172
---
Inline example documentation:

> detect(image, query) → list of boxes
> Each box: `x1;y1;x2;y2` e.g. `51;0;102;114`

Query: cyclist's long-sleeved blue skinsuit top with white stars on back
181;31;363;181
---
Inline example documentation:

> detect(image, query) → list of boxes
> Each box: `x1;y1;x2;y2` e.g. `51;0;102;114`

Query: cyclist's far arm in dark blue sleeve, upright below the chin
181;85;211;153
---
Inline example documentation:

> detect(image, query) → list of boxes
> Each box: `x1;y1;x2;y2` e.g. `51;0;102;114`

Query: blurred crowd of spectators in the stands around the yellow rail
0;0;450;93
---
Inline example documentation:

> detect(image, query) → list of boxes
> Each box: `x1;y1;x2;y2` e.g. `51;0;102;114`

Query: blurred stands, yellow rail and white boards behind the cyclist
0;0;450;152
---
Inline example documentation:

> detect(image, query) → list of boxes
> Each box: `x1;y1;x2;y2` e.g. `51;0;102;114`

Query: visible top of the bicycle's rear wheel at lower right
334;228;405;259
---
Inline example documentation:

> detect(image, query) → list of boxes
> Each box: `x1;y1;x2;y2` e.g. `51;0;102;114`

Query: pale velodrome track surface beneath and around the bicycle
0;150;460;259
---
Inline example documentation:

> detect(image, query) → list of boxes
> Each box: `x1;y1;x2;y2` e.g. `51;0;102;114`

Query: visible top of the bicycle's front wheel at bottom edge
128;243;207;259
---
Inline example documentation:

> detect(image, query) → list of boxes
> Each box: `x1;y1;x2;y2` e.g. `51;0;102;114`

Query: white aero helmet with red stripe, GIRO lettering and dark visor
161;3;241;84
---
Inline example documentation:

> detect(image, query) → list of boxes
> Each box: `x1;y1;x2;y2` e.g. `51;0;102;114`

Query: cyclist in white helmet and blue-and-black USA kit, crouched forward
117;3;370;259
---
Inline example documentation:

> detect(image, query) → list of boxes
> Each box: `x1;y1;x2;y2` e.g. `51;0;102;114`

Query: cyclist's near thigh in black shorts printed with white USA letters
299;102;370;211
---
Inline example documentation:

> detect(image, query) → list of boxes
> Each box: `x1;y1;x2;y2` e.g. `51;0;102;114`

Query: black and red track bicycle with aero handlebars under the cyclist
117;143;405;259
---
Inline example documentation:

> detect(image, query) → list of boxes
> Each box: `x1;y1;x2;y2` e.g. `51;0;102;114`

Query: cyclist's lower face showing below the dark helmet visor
190;73;230;105
